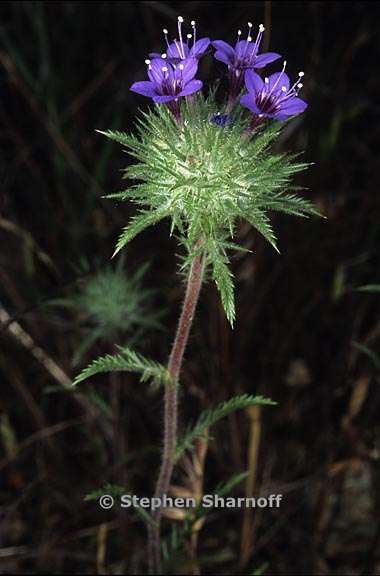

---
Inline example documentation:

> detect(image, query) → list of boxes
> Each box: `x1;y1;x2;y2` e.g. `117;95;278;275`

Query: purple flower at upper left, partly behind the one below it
149;16;210;64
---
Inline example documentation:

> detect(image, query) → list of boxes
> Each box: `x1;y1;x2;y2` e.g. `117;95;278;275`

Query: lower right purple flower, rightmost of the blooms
240;62;307;124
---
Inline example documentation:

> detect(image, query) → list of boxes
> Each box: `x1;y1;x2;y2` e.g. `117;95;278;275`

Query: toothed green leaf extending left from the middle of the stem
73;347;171;386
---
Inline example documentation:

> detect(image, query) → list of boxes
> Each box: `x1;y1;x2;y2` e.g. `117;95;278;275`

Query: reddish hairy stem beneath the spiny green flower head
149;243;204;574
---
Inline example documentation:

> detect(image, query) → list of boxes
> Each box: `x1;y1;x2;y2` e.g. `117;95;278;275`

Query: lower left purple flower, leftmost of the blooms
131;58;202;104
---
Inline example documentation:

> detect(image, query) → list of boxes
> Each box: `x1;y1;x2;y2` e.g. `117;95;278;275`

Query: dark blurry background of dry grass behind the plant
0;2;380;575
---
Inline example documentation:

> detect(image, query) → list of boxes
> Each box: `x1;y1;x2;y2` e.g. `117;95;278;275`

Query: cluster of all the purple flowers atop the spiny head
131;16;307;129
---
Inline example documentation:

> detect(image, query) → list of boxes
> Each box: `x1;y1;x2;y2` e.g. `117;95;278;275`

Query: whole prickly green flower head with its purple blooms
104;17;317;324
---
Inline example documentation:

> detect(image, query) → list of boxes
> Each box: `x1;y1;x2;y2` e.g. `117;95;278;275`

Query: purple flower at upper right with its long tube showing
212;22;281;100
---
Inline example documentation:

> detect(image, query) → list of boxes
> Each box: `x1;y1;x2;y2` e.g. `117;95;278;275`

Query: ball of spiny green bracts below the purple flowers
102;95;318;324
